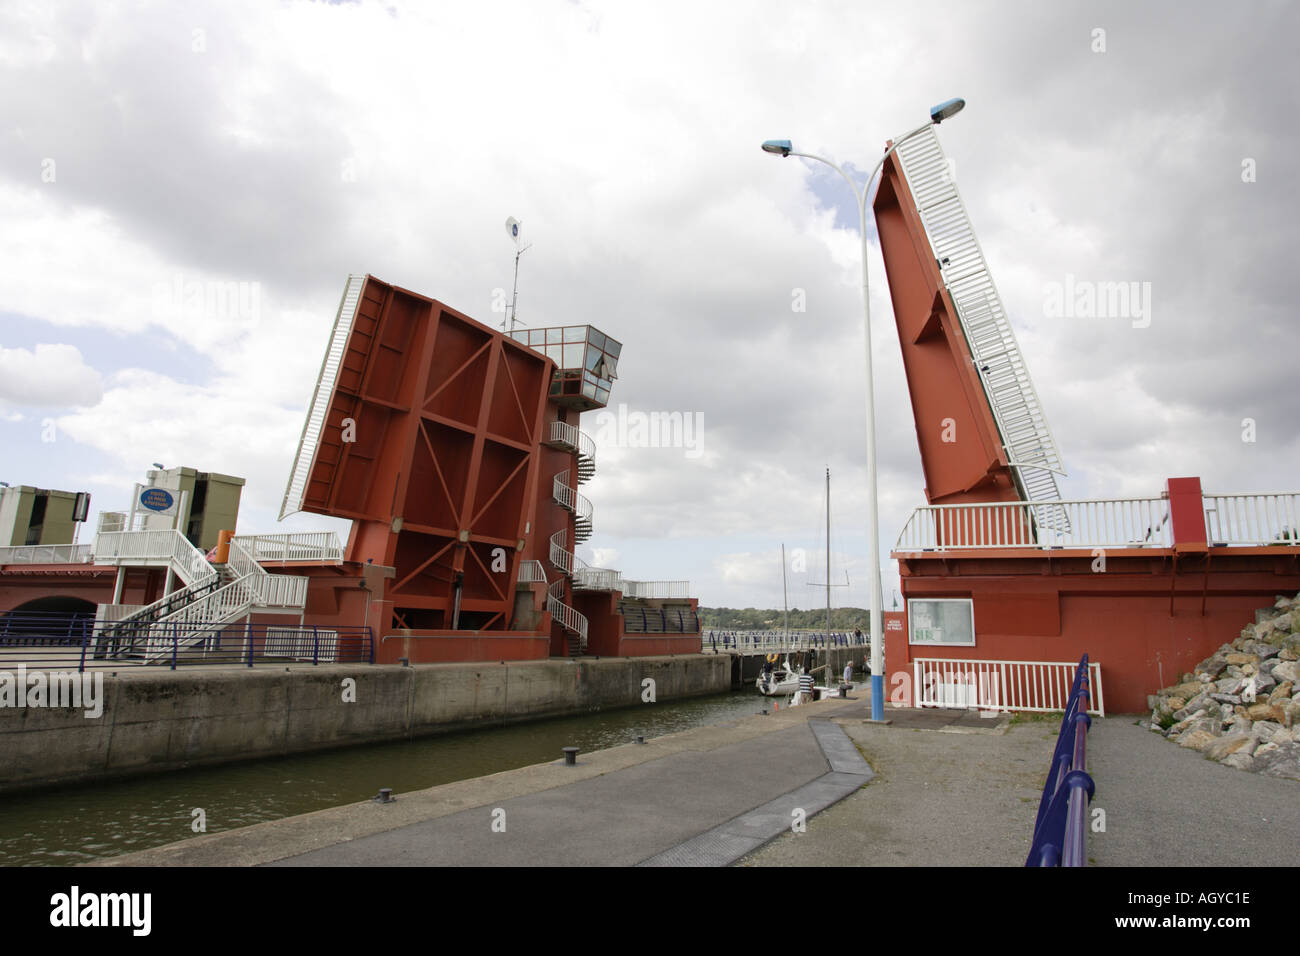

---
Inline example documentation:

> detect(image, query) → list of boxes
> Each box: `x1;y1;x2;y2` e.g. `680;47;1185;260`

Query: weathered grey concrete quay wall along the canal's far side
0;654;731;792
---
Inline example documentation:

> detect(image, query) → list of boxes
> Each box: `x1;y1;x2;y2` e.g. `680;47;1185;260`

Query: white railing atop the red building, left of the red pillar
894;498;1173;551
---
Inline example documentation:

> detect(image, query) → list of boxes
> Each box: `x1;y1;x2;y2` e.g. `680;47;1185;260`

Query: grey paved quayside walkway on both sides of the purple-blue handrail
101;700;1300;866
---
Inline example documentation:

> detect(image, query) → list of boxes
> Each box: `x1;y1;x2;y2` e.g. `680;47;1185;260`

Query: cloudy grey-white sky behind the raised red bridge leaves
0;0;1300;606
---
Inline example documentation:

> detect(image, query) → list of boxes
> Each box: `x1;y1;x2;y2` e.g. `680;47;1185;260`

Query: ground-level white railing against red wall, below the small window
913;657;1106;717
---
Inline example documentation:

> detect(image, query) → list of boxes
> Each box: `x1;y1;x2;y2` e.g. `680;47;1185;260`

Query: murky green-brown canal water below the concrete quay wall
0;688;764;866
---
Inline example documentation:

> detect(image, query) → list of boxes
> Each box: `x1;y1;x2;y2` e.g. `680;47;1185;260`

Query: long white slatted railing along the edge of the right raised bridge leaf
896;127;1065;515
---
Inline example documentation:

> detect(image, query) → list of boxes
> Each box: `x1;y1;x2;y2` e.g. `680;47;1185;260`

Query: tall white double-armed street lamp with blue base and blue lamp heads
763;99;966;721
